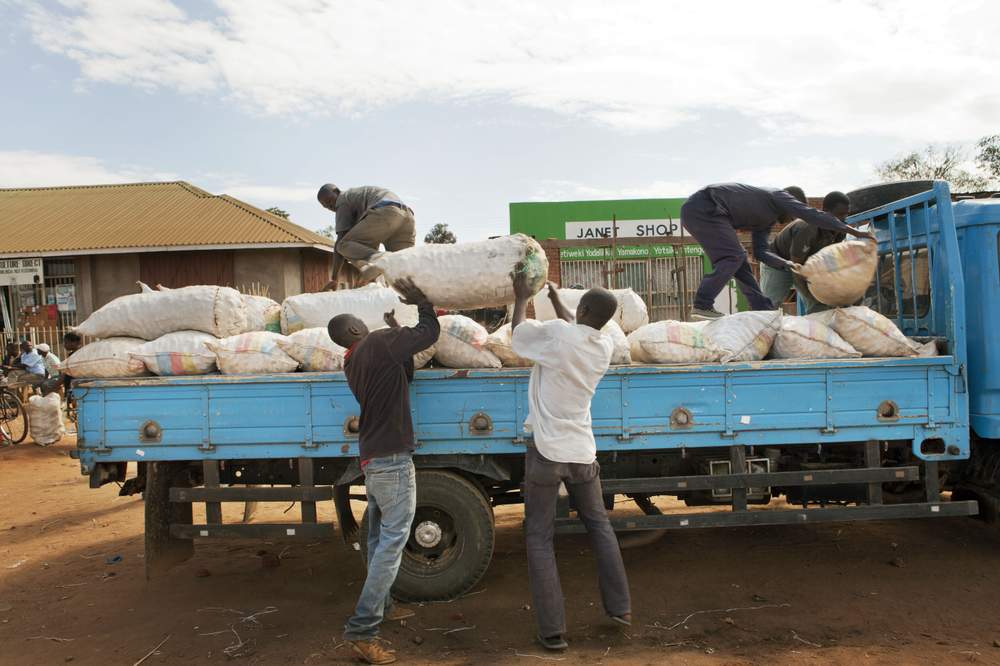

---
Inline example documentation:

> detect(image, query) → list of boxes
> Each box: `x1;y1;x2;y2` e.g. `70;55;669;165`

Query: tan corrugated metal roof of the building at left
0;181;332;255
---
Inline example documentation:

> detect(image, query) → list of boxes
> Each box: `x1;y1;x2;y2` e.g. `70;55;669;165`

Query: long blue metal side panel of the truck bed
76;357;968;472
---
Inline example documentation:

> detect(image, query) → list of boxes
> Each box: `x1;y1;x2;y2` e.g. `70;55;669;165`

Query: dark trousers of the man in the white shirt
524;447;632;637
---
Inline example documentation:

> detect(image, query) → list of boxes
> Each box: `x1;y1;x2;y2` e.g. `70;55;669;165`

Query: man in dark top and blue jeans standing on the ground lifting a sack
327;280;441;664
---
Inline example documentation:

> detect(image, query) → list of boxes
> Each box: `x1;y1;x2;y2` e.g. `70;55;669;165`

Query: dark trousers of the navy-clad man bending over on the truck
681;192;775;310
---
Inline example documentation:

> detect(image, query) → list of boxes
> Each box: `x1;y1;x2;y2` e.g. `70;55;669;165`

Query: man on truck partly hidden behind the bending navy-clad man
760;192;851;314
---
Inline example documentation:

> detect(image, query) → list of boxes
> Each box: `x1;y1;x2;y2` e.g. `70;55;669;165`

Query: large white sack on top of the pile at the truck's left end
75;286;247;340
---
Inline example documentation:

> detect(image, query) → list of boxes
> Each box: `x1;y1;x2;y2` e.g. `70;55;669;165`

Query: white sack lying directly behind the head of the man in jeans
281;284;420;335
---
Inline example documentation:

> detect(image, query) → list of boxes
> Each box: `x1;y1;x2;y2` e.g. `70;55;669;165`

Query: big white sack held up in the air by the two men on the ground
372;234;549;308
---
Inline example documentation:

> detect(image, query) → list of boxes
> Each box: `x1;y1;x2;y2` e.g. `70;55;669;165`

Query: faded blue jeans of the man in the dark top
344;453;417;641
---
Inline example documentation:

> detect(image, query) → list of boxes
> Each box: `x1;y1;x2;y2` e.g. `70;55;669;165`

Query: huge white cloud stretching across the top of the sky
28;0;1000;142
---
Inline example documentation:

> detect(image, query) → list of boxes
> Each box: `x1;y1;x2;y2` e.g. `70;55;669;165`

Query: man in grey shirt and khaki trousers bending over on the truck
316;183;417;290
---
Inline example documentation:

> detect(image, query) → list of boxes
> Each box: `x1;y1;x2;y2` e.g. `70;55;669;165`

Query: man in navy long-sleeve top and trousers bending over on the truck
681;183;870;319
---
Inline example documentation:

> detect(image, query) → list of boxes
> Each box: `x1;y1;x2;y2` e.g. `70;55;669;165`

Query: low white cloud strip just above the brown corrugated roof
0;150;177;187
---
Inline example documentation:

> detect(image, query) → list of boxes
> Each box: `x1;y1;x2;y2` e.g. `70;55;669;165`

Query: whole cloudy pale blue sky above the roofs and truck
0;0;1000;240
